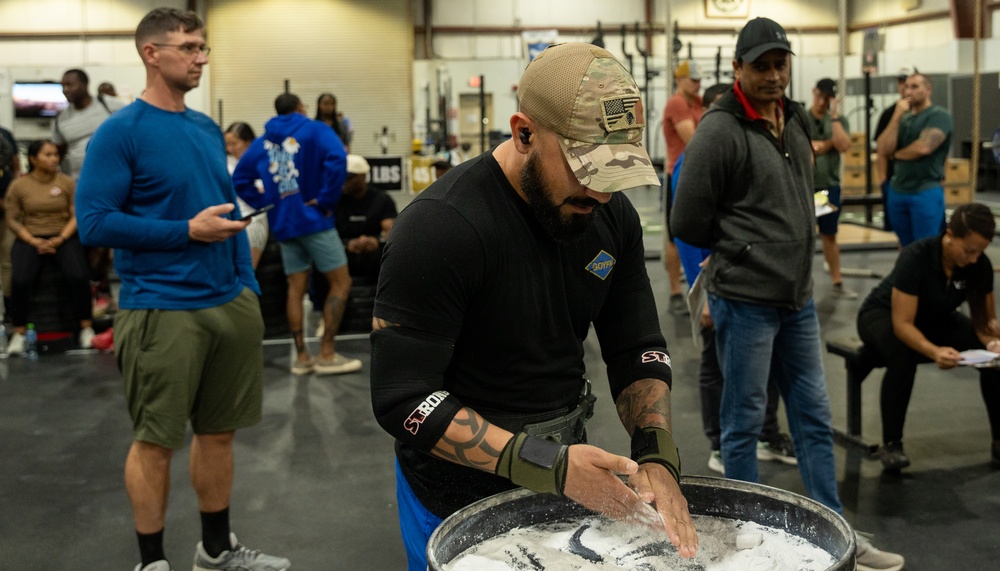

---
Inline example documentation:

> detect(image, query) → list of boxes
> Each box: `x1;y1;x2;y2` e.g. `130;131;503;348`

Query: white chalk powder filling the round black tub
444;516;835;571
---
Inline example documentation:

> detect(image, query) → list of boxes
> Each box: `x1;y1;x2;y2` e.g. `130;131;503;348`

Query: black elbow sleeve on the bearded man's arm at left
371;328;462;451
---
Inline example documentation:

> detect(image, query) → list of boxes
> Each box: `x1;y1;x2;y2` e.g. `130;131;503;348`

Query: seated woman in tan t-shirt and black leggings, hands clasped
5;140;94;353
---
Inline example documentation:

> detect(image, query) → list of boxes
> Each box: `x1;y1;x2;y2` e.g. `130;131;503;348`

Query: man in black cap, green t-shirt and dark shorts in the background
809;78;858;299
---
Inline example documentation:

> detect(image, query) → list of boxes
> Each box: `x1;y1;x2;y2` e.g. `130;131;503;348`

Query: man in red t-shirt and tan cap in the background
663;61;702;315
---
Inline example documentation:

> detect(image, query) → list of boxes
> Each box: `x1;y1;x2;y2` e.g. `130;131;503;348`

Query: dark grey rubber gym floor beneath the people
0;191;1000;571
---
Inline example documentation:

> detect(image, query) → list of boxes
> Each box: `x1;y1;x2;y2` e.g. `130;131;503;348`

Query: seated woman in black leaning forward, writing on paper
858;204;1000;471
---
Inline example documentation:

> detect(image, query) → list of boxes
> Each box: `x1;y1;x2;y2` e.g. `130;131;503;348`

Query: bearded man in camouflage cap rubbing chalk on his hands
371;43;697;570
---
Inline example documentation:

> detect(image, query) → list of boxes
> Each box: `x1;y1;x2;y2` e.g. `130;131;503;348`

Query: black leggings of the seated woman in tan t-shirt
9;234;93;327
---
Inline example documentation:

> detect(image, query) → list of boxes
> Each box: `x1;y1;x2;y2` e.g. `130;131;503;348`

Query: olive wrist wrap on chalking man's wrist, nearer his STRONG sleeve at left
496;432;569;496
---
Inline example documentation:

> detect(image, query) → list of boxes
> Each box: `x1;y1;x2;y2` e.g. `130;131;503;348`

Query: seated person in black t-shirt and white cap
336;155;396;284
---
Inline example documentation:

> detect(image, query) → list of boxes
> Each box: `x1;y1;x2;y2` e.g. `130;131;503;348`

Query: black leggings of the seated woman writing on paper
858;308;1000;443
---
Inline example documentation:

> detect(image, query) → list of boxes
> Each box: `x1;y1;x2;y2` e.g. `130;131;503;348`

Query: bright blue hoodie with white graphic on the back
233;113;347;242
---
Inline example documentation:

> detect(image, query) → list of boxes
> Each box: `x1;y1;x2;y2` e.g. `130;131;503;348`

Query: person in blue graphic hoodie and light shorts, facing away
233;93;361;375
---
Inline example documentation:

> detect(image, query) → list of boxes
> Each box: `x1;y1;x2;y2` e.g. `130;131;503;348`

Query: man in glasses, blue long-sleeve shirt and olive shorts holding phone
76;8;290;571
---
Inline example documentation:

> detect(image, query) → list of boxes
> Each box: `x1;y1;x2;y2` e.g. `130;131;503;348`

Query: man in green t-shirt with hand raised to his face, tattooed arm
878;73;952;246
